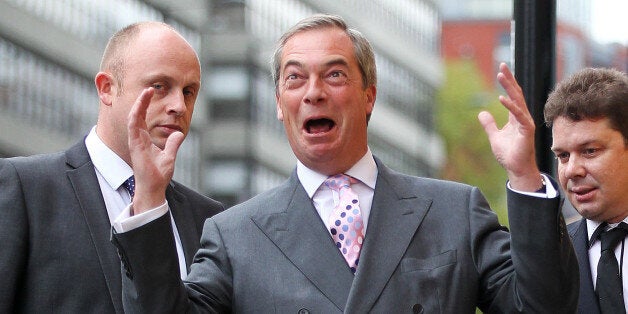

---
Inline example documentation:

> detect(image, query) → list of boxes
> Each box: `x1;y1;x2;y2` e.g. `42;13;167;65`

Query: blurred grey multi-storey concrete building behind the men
0;0;445;209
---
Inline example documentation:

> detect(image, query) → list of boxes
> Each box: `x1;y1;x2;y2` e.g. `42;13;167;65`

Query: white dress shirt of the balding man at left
85;127;187;279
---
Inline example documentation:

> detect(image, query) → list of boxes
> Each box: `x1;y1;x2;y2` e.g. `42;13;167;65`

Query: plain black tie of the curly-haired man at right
595;222;628;314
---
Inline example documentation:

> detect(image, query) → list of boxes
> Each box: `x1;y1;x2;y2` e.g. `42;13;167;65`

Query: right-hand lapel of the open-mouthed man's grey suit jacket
345;159;431;313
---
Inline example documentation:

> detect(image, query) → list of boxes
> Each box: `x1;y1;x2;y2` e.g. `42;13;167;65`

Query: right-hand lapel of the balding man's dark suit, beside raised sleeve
166;182;199;272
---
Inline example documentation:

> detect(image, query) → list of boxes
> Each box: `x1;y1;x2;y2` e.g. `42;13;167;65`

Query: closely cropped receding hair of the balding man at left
100;21;177;93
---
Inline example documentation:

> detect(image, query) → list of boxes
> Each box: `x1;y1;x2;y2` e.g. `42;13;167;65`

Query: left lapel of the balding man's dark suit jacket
66;142;123;313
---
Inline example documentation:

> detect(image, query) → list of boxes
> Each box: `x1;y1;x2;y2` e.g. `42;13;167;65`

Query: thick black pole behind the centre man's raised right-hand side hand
513;0;556;174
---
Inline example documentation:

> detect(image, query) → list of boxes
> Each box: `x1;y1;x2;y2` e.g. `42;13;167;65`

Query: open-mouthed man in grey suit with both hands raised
114;15;578;313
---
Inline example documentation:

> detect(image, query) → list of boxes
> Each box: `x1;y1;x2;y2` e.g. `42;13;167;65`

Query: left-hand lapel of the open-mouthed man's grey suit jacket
251;172;353;311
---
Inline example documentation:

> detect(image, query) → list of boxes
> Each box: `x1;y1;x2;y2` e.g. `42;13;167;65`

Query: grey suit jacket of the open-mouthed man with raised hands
115;160;578;313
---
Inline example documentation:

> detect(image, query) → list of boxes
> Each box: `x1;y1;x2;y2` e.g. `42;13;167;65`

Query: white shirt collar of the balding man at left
85;126;133;190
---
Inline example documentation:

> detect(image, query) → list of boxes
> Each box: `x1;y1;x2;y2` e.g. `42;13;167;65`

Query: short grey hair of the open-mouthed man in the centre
271;14;377;91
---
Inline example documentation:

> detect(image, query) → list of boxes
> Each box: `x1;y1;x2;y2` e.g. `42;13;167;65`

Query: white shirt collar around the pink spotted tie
297;148;377;198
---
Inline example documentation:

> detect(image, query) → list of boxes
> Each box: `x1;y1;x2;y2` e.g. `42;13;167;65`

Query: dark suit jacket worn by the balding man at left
0;141;222;313
